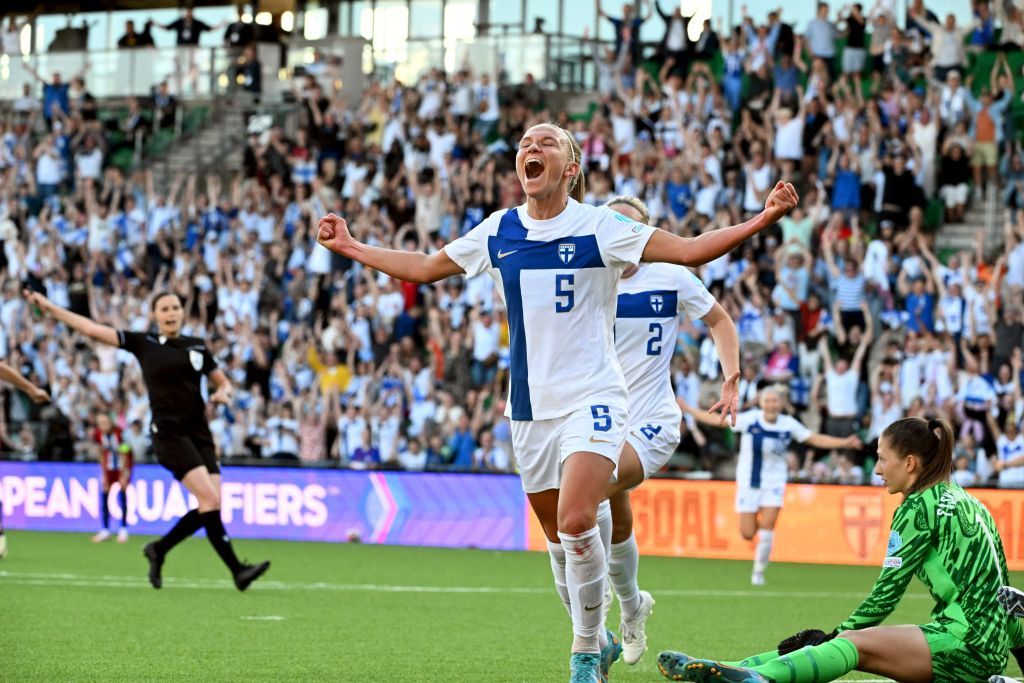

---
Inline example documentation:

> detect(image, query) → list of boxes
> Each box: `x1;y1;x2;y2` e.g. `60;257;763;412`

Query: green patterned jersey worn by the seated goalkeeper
839;481;1024;653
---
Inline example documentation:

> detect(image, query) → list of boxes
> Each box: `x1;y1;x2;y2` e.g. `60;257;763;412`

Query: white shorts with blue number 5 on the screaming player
512;398;629;494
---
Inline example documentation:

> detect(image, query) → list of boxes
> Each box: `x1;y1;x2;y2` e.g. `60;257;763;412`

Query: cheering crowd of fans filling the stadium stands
0;0;1024;486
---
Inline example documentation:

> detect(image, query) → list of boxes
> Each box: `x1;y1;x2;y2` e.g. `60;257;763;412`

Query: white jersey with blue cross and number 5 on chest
444;199;656;420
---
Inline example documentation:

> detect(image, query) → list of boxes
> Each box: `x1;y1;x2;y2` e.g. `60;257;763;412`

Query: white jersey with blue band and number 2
615;263;715;426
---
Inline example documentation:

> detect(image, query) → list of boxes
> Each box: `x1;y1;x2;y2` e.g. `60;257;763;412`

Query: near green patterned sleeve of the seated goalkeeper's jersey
839;496;933;632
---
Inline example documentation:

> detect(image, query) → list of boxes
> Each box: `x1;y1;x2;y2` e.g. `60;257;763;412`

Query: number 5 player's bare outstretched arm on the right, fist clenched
640;182;800;266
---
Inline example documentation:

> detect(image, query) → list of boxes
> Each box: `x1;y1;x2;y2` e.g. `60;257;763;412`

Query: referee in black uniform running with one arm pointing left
24;290;270;591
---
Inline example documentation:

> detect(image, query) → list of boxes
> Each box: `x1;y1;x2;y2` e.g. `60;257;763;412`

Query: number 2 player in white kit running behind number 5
604;197;739;665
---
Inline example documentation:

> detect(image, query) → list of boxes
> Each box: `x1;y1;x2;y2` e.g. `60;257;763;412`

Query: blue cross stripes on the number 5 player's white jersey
487;209;604;420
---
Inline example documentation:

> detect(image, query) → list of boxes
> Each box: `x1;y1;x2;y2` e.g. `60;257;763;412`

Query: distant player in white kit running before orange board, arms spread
683;387;862;586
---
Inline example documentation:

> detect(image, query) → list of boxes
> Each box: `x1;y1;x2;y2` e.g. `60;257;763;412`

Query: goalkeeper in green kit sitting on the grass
658;418;1024;683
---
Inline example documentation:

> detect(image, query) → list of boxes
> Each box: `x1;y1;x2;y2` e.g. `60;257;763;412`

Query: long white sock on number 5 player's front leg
558;525;608;654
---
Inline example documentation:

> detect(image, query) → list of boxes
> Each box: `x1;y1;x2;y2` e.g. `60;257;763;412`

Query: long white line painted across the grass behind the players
0;571;930;600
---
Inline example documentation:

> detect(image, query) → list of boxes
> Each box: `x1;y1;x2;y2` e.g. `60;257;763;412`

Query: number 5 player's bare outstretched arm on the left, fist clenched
316;213;465;284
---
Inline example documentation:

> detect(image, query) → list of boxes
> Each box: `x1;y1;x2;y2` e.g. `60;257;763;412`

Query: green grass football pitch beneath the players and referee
0;531;1024;683
